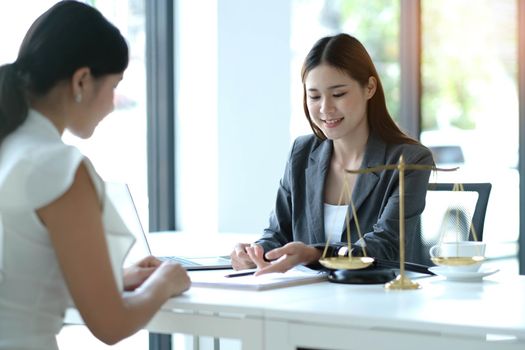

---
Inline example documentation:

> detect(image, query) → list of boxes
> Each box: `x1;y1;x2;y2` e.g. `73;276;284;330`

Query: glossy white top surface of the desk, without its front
159;275;525;339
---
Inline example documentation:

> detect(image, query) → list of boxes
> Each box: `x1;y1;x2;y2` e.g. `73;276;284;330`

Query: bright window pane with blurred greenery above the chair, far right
421;0;519;256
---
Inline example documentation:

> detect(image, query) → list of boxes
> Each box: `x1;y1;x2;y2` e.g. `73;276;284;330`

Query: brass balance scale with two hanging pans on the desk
319;155;481;290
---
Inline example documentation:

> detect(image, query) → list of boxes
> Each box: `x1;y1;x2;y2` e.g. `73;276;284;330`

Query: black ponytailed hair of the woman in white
0;1;128;142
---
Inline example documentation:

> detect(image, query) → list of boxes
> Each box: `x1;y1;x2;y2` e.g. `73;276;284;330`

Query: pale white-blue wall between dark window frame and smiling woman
176;0;291;233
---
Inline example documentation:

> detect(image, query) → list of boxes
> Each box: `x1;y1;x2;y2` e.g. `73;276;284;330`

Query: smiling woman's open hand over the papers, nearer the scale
245;242;321;276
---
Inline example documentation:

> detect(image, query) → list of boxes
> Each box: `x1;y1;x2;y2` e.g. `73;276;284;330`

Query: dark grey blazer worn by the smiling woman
257;133;434;261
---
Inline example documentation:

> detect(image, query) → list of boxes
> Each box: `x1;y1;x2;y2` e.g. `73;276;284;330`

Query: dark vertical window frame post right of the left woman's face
146;0;176;235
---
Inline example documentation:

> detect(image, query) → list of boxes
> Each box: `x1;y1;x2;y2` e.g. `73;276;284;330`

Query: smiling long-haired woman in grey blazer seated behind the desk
231;34;433;274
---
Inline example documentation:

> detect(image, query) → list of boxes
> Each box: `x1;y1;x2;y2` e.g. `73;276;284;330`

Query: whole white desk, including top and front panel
147;274;525;350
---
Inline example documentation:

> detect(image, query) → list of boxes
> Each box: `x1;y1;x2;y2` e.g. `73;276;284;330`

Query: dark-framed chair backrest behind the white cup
406;183;492;266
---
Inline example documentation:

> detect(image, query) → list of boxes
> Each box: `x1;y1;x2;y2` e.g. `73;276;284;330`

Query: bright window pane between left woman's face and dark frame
64;0;149;228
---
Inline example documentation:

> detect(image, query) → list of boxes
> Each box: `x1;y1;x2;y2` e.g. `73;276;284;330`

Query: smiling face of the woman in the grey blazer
304;64;375;140
